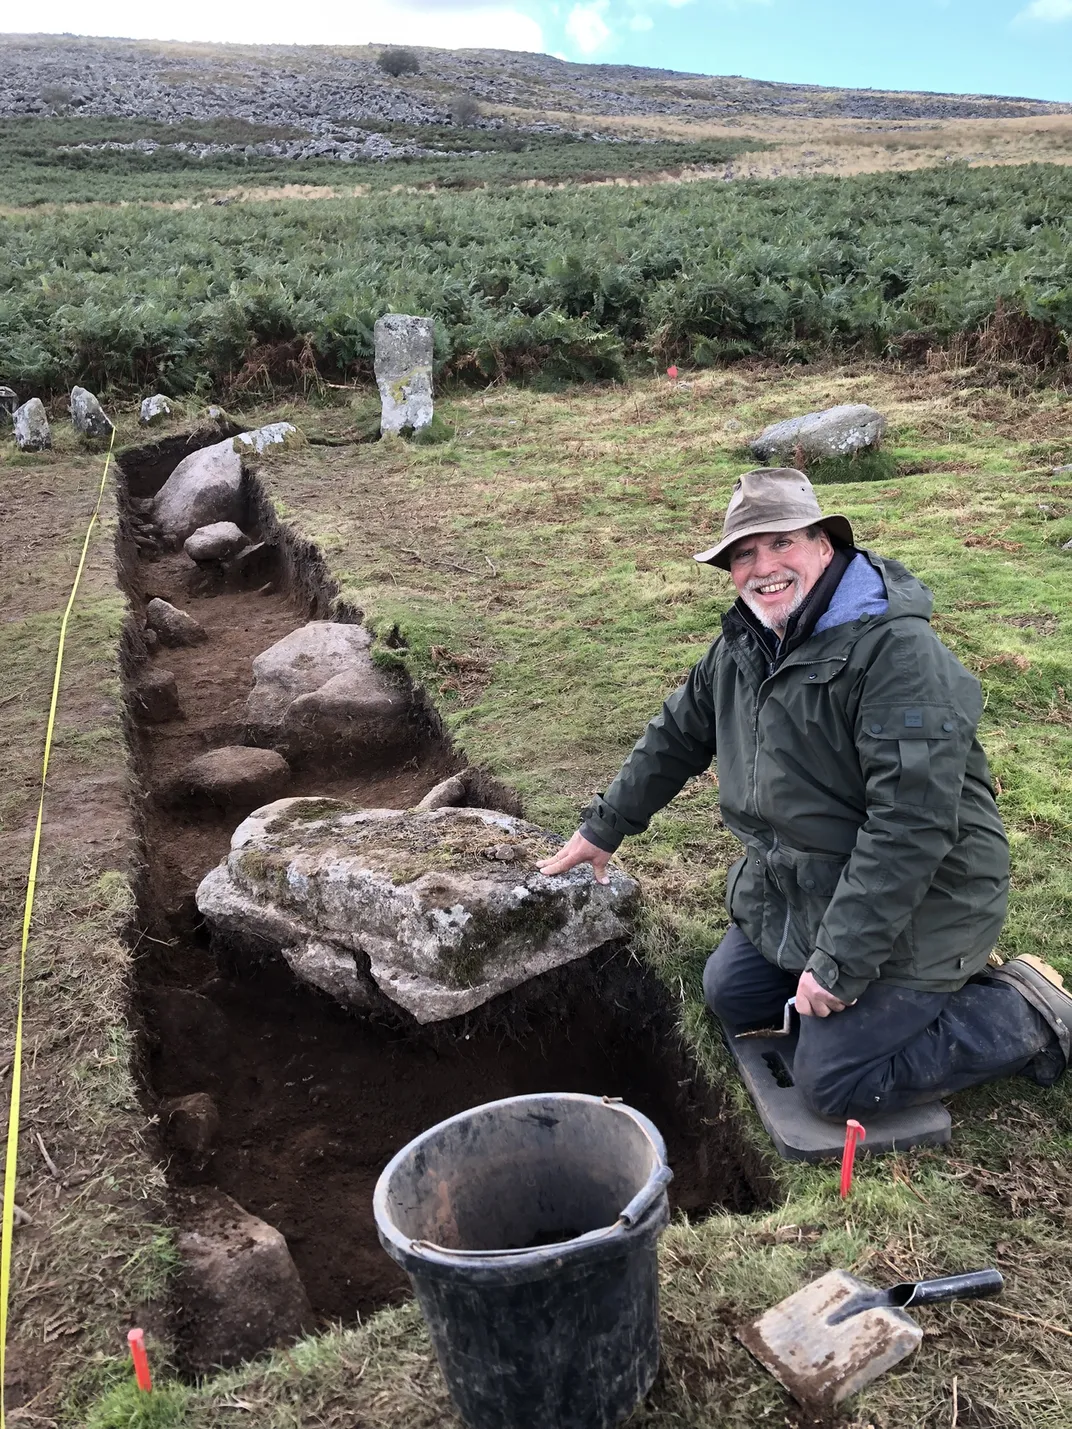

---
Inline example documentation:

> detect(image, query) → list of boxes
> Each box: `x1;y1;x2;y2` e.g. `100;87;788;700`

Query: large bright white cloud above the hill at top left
4;0;546;51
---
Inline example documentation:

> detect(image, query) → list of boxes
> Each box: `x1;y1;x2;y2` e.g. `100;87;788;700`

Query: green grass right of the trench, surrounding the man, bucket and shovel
12;366;1072;1429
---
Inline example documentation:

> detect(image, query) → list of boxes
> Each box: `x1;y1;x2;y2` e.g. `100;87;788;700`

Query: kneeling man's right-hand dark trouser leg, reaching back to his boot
793;982;1055;1120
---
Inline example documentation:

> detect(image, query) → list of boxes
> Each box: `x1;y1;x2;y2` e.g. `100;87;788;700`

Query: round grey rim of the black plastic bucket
372;1092;673;1270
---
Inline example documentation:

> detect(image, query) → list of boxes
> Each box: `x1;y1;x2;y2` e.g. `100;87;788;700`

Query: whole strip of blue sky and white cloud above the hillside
8;0;1072;100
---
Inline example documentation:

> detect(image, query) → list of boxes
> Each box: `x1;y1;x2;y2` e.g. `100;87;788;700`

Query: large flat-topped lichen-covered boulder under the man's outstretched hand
197;799;636;1023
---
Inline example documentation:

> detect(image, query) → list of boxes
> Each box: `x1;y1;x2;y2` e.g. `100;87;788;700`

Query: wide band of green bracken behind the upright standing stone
0;164;1072;396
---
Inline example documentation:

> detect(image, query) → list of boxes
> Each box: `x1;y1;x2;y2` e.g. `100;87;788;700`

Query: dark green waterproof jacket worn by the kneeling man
582;552;1009;1002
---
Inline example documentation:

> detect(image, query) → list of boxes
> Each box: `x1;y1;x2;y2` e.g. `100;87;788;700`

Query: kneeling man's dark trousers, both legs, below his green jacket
703;925;1063;1117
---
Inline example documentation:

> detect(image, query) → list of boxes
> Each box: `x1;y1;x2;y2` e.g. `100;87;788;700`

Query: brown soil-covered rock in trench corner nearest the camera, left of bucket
177;1186;313;1373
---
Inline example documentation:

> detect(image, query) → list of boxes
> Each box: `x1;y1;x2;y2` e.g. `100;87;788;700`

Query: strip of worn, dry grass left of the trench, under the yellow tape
0;427;174;1425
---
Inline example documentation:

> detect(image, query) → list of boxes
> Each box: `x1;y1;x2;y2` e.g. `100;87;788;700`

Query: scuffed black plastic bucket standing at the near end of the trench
373;1092;673;1429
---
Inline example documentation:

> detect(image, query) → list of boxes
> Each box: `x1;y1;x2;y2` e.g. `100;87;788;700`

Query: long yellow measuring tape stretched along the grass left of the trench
0;427;116;1429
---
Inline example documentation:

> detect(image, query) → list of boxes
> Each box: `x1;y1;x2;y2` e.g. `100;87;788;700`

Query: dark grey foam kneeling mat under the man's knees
722;1025;952;1160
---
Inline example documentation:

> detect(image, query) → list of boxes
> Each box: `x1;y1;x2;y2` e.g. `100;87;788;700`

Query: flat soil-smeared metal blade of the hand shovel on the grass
736;1270;923;1409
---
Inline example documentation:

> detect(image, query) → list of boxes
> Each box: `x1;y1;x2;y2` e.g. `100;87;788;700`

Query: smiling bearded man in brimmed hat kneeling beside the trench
542;469;1072;1117
